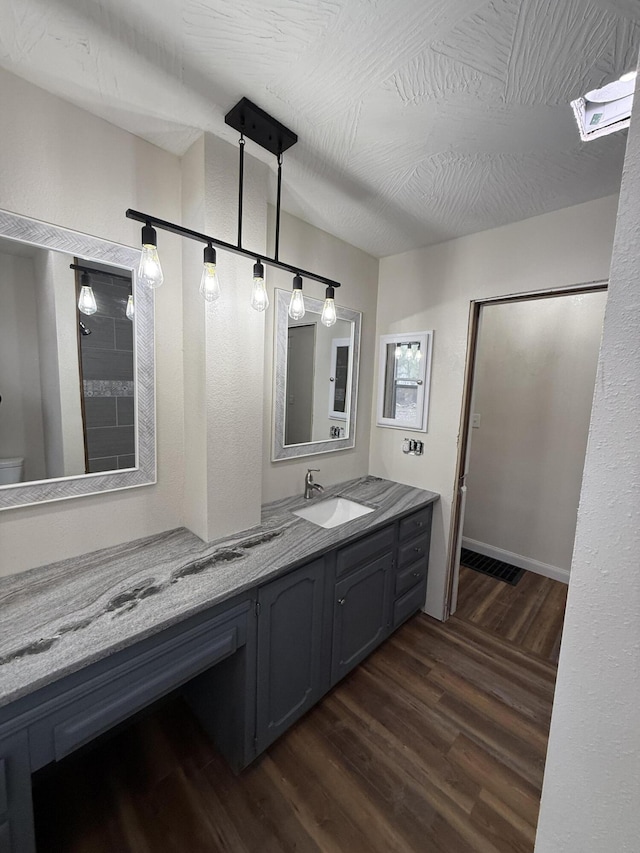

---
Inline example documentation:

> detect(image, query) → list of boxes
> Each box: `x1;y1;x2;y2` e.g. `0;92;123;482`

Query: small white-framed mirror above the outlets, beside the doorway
377;332;433;432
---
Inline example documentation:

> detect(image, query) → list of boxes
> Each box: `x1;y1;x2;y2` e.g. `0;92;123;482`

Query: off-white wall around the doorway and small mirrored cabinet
370;197;617;618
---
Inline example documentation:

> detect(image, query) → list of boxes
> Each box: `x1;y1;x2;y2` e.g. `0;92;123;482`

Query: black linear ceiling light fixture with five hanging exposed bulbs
126;98;340;314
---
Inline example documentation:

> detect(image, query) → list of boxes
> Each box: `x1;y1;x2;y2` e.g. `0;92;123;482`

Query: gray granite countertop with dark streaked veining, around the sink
0;477;438;706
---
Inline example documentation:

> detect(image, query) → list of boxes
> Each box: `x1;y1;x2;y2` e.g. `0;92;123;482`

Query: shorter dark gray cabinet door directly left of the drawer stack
331;553;393;684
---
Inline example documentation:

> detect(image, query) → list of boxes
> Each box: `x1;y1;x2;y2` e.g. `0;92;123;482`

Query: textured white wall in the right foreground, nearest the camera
536;75;640;853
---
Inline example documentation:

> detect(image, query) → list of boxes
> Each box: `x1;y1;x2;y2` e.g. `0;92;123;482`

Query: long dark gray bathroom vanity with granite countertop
0;477;438;853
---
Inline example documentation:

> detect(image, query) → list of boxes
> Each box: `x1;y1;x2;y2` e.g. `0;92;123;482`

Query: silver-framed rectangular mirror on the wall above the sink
272;289;362;462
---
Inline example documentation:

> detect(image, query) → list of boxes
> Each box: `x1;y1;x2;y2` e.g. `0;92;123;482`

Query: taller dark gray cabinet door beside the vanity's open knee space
256;560;325;753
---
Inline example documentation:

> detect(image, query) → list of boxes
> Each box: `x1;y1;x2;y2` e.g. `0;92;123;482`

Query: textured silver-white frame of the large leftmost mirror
0;210;156;510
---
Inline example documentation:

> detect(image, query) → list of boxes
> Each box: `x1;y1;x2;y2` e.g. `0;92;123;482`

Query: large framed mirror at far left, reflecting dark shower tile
0;211;156;509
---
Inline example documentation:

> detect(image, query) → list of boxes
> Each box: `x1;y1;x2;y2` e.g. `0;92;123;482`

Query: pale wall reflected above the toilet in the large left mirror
0;253;45;480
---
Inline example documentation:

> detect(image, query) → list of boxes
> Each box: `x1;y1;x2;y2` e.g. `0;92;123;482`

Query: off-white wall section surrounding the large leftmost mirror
0;65;183;574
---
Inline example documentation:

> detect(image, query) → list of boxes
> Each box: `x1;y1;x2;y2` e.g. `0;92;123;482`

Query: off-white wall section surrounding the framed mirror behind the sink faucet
262;208;378;502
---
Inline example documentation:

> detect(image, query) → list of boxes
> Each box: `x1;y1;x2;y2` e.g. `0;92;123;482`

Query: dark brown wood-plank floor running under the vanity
34;573;556;853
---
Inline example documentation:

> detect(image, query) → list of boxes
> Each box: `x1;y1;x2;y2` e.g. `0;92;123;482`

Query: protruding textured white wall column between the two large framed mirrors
183;134;267;541
